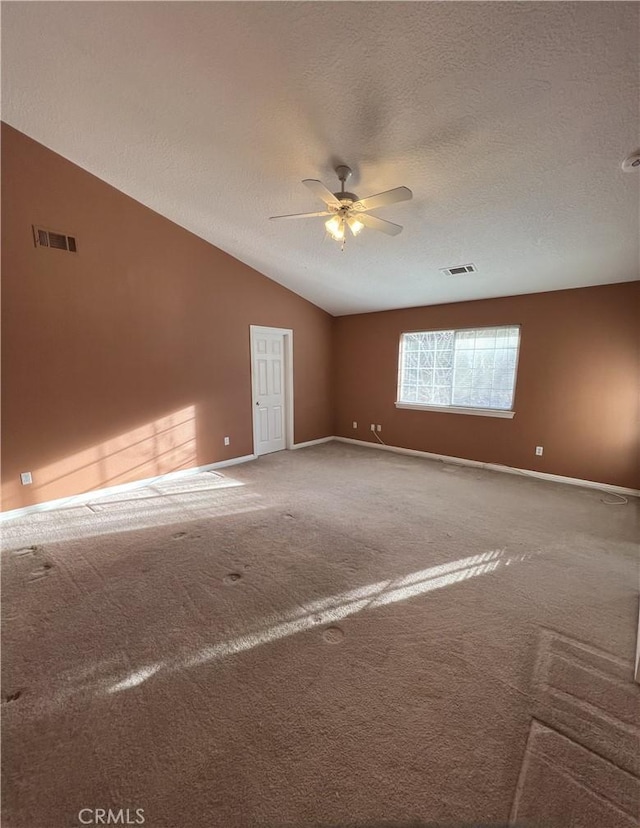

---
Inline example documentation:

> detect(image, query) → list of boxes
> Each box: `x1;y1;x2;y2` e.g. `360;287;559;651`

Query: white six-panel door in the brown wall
251;327;286;454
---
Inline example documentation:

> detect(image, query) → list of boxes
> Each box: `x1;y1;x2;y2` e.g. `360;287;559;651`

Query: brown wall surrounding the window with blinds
334;282;640;488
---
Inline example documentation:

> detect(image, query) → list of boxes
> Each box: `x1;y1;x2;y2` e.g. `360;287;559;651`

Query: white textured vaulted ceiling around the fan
2;2;640;314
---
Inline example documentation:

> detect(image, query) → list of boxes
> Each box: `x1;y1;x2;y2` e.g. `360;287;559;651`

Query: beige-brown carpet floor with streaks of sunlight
2;443;640;828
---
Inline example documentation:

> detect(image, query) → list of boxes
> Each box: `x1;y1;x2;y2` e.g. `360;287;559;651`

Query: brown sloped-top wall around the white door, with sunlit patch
2;124;333;510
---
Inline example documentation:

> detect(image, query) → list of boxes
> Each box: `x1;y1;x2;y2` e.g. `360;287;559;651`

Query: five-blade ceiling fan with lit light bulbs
271;165;413;250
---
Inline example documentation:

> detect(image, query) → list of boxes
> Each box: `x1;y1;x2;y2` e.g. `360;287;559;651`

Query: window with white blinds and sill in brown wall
396;325;520;417
